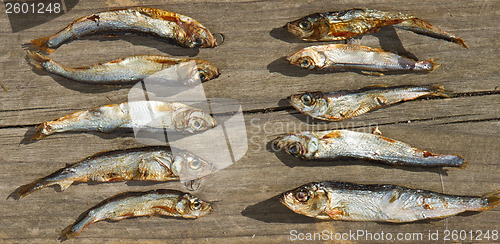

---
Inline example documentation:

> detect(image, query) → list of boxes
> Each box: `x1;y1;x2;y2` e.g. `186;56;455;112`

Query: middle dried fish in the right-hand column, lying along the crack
290;85;449;121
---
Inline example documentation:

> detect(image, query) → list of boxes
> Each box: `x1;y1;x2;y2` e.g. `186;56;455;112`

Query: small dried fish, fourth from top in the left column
15;146;215;198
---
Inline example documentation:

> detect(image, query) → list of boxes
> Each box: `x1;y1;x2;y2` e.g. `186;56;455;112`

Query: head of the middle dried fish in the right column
289;92;328;117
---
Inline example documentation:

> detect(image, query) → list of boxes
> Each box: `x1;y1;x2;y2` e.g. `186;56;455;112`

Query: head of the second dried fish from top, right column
286;47;327;70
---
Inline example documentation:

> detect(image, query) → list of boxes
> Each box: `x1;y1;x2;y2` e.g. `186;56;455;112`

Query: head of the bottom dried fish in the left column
176;193;213;219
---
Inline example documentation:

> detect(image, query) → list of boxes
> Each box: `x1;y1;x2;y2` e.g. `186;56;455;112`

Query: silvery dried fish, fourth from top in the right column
275;130;466;168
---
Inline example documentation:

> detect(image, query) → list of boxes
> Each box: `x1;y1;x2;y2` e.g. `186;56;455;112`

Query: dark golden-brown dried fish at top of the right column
286;8;467;48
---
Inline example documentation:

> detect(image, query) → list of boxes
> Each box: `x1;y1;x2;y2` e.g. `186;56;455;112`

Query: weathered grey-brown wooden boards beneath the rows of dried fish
0;0;500;243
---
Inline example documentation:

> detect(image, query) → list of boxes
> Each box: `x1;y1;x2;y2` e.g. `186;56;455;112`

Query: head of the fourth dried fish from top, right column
274;132;319;159
